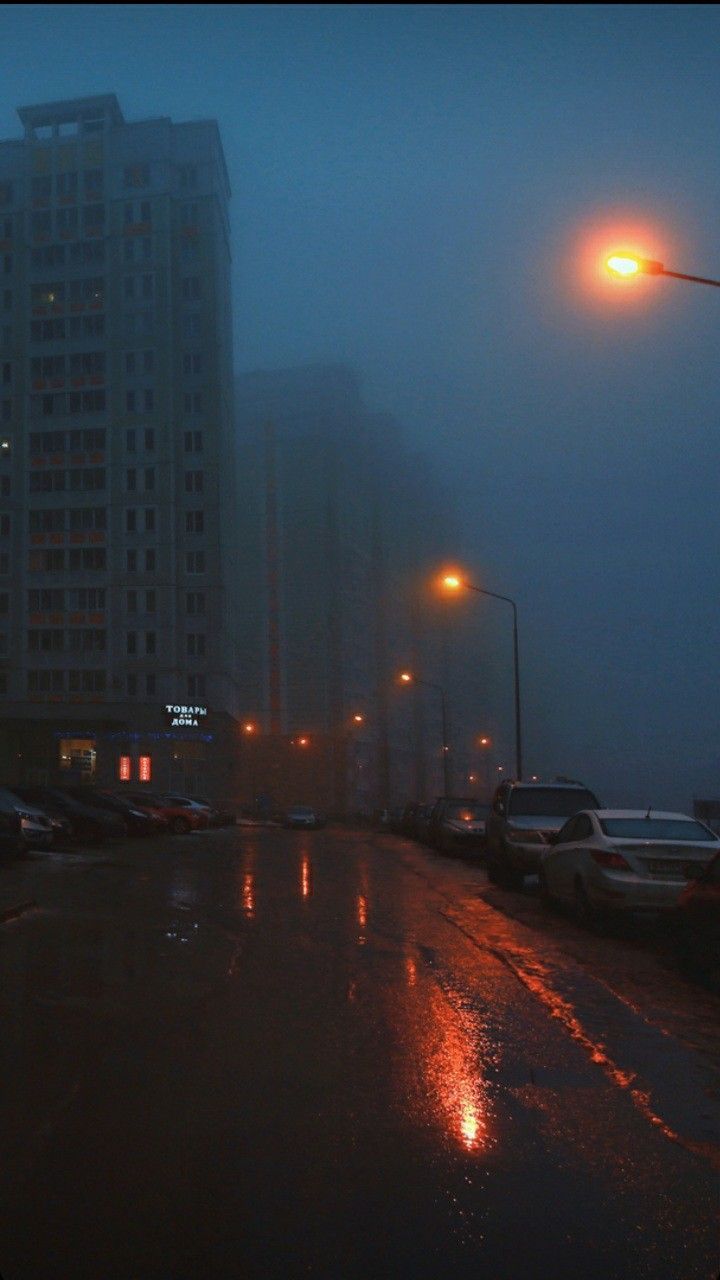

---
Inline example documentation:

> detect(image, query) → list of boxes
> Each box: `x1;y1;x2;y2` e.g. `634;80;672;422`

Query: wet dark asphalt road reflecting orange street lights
0;828;720;1280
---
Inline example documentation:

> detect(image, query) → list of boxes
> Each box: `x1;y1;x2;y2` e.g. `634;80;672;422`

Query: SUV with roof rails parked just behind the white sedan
486;778;601;888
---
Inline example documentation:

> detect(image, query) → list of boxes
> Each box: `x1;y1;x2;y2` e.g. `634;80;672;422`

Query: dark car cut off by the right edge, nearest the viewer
669;851;720;991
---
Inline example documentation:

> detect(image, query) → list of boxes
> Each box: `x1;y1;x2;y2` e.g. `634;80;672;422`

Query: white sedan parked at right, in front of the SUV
539;809;720;923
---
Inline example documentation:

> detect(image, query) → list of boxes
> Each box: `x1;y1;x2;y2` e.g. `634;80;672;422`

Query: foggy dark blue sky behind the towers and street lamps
0;4;720;808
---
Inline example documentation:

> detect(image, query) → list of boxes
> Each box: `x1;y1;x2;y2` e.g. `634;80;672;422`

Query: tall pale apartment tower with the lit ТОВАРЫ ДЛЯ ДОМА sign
0;95;241;795
